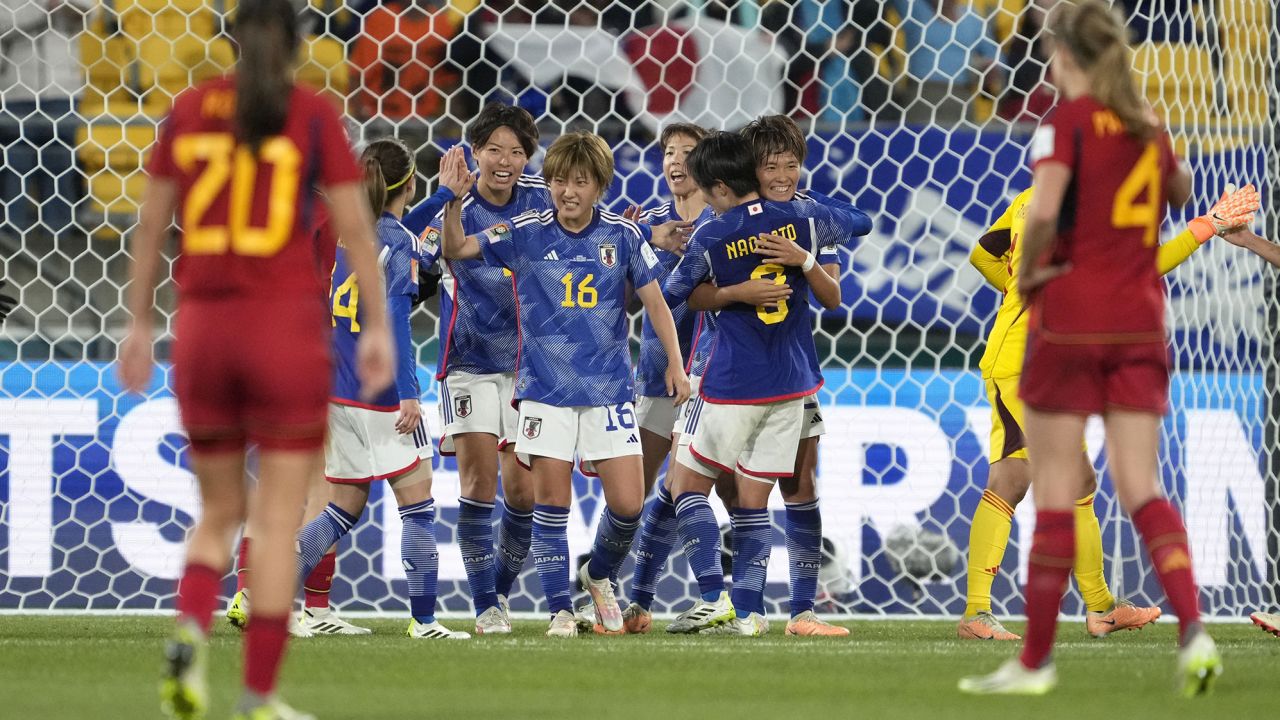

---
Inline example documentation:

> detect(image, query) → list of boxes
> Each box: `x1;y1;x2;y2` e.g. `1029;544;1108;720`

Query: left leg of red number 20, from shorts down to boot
160;448;248;720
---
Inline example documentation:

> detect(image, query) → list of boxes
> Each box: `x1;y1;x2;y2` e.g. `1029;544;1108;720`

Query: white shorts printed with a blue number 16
516;400;641;475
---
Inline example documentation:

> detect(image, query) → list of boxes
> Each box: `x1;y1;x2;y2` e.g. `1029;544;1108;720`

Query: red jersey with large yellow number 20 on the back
147;77;361;299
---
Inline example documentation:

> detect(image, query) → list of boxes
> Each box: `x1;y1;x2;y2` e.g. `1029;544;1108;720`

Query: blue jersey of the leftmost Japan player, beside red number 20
329;213;421;411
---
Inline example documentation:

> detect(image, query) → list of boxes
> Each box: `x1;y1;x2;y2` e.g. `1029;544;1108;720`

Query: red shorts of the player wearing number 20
173;299;333;452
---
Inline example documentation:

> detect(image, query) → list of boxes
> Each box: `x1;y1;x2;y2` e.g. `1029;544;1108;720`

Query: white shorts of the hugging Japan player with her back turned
676;397;804;483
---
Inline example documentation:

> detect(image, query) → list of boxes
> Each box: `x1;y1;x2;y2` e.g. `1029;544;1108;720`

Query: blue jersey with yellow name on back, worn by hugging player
663;200;847;405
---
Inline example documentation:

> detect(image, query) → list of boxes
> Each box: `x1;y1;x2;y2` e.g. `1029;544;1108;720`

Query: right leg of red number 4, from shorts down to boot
1103;409;1222;697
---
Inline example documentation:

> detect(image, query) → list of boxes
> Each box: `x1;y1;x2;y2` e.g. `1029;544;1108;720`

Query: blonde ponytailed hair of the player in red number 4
1050;0;1156;140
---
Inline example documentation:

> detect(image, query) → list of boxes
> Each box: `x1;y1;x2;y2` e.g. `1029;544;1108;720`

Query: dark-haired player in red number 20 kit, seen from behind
119;0;393;720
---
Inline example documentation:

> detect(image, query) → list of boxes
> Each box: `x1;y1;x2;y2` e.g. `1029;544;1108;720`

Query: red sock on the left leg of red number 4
1021;510;1075;670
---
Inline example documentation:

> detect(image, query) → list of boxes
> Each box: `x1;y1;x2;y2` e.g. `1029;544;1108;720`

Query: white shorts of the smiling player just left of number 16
440;373;520;455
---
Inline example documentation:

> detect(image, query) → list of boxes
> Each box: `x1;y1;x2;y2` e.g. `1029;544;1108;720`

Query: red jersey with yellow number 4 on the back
1030;96;1178;343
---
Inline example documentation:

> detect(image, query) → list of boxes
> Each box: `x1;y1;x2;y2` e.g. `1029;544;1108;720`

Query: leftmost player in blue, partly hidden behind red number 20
298;138;471;639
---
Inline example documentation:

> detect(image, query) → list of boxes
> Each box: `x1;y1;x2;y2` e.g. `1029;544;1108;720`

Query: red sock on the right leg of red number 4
1133;497;1199;634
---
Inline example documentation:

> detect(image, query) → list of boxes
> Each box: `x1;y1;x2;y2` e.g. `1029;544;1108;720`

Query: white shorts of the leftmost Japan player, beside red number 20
324;402;431;483
